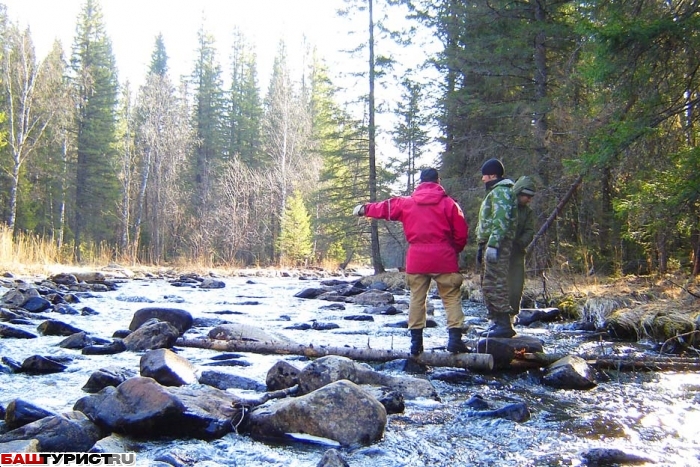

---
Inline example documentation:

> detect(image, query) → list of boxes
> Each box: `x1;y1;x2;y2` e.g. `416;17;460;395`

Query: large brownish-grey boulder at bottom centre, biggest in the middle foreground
246;380;387;446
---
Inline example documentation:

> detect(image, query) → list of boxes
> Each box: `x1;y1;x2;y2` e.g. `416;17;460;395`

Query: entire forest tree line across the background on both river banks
0;0;700;274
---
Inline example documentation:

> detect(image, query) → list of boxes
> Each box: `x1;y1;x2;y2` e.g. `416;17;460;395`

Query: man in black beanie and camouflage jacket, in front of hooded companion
476;159;517;337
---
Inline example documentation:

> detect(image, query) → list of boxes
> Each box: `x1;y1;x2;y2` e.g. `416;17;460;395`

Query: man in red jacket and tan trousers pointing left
353;168;469;355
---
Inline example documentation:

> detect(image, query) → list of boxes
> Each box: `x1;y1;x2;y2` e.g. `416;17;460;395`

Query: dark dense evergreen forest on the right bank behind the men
409;0;700;274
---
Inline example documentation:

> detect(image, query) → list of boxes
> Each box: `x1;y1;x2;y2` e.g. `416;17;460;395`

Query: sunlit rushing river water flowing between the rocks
0;277;700;467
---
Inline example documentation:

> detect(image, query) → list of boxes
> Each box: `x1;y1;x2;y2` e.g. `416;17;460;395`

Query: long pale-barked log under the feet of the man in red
175;338;493;371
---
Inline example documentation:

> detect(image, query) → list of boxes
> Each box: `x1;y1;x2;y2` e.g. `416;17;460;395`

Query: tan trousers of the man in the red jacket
406;272;464;329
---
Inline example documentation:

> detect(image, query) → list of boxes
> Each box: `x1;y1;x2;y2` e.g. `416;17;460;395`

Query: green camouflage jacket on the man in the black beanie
476;178;516;248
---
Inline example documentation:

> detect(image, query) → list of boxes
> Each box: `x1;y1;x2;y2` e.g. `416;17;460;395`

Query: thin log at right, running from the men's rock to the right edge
511;352;700;371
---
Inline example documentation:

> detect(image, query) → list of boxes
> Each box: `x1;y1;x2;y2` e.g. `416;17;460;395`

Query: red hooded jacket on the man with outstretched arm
365;182;469;274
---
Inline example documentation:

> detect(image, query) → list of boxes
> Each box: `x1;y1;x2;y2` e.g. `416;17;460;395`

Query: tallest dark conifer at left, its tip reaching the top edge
71;0;119;261
